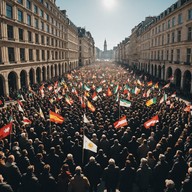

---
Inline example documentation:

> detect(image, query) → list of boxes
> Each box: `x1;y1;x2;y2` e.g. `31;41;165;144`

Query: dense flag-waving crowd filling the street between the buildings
0;63;192;192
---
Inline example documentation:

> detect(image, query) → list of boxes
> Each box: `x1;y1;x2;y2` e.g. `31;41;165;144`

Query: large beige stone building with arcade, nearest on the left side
0;0;95;95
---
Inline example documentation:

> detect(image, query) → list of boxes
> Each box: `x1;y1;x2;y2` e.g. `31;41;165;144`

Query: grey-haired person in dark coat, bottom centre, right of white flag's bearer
103;159;120;192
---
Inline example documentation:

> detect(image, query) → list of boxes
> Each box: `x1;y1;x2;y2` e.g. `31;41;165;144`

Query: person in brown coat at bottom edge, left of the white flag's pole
68;166;90;192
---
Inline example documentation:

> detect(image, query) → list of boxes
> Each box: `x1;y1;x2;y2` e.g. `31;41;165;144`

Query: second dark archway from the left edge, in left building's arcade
8;71;18;96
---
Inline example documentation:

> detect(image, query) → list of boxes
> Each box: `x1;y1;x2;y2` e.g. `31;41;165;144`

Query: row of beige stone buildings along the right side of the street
115;0;192;94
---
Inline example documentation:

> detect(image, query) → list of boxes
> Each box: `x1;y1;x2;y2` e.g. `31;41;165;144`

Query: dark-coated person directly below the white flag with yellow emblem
84;156;102;192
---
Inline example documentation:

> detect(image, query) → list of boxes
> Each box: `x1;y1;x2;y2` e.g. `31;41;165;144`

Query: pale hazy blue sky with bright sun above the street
56;0;177;50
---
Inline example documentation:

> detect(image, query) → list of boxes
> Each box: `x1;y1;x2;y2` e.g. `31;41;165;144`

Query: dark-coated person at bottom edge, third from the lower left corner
39;164;57;192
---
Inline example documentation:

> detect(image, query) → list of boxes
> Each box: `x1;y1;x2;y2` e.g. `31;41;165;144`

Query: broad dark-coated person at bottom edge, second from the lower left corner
20;165;41;192
